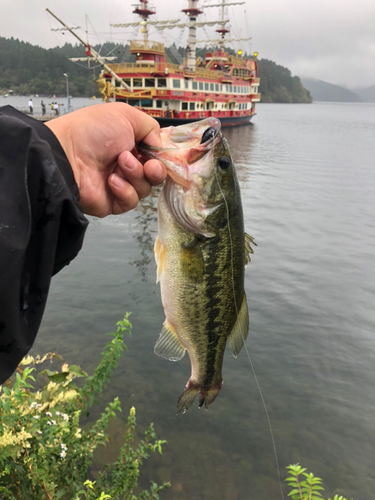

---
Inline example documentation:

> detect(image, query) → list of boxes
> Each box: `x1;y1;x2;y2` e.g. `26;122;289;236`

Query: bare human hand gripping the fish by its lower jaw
46;103;167;217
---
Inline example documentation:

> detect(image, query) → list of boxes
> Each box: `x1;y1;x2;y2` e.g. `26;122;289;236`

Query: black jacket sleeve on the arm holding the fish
0;106;88;384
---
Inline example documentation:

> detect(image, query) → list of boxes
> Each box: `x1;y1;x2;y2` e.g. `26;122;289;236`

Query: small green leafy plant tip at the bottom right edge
285;464;354;500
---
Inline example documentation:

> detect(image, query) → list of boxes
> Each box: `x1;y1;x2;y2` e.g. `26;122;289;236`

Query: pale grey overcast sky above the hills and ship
0;0;375;88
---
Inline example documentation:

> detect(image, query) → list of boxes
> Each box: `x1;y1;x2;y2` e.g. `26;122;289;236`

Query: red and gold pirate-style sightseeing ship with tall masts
47;0;260;127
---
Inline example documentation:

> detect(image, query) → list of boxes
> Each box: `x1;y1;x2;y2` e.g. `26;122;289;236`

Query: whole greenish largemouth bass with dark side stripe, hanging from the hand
138;118;253;413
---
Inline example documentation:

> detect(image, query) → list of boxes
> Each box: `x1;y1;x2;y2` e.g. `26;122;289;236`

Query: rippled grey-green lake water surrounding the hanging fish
33;104;375;500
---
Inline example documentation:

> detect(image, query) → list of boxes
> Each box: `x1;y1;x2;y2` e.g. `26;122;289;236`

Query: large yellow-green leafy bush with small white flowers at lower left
0;314;170;500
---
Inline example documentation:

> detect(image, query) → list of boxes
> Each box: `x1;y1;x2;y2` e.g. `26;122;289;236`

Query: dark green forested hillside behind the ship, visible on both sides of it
0;37;311;102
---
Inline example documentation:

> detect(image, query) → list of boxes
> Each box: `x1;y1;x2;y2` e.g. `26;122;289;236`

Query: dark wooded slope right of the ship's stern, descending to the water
258;59;312;103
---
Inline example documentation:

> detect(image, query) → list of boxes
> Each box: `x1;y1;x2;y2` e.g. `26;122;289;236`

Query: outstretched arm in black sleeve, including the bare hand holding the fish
0;103;167;384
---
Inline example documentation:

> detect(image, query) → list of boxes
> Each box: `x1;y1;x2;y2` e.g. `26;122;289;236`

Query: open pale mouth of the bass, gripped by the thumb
137;117;221;188
